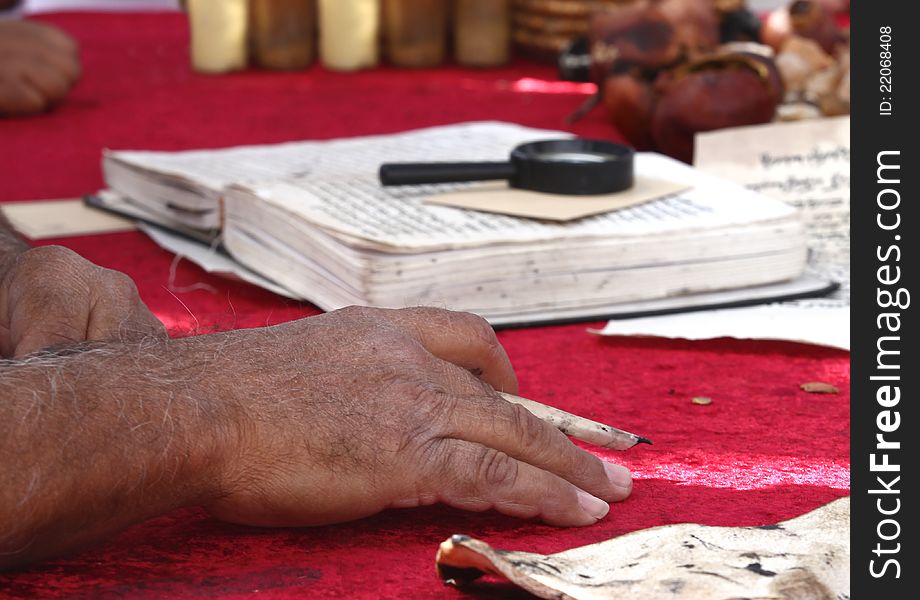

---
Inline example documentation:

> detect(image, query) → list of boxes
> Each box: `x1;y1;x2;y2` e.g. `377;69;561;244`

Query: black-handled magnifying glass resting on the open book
380;139;635;196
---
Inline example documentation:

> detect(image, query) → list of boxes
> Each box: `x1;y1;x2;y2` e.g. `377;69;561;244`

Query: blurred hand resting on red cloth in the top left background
0;21;80;116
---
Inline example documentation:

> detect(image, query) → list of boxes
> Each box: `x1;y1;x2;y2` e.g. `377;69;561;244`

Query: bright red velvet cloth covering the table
0;14;849;598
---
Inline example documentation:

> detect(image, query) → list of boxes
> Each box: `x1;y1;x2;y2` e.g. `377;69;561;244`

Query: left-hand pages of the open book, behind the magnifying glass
102;121;571;229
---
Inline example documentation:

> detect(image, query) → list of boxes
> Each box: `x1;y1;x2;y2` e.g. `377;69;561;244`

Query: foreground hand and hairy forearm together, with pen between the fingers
0;296;632;569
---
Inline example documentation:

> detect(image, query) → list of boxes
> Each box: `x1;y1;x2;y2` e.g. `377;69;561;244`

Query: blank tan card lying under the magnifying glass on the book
424;177;687;222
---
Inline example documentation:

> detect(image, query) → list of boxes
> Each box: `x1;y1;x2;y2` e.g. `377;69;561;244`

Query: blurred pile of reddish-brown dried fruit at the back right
588;0;850;163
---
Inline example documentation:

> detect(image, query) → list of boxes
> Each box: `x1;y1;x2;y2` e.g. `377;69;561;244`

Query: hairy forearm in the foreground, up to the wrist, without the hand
0;335;241;569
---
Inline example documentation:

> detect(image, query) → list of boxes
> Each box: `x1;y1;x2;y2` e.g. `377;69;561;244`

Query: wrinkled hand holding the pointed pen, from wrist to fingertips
203;308;632;526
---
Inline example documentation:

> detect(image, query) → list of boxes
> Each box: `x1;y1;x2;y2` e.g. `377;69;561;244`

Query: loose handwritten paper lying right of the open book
597;117;850;350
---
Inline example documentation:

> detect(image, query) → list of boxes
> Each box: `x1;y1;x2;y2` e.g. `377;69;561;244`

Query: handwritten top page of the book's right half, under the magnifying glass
227;153;794;252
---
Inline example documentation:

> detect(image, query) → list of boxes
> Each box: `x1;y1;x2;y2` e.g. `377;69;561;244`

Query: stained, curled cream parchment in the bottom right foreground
437;498;850;600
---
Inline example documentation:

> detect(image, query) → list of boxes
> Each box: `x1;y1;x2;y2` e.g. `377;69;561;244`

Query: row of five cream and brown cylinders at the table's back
184;0;511;73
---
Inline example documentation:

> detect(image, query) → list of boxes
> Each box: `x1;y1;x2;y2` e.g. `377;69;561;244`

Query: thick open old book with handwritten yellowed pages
97;122;825;324
